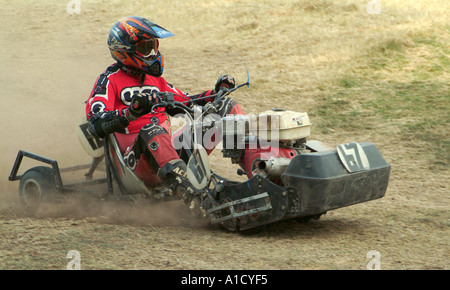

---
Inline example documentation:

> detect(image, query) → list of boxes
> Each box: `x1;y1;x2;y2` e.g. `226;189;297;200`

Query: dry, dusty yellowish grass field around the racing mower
0;0;450;270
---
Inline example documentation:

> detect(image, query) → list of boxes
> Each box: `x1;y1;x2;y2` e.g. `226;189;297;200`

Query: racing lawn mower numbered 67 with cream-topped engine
9;77;390;231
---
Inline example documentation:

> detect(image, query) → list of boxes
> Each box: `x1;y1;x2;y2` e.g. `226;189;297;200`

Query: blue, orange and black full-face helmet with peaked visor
108;16;174;77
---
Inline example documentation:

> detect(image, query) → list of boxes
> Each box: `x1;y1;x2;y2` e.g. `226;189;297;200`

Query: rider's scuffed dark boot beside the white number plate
158;159;210;217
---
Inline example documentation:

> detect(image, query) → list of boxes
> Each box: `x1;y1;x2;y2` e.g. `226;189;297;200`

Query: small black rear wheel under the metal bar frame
19;166;56;213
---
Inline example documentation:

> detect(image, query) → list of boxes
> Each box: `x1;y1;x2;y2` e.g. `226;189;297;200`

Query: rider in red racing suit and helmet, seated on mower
86;16;243;211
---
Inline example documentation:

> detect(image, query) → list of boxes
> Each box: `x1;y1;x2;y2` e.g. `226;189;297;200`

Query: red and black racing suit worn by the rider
86;64;243;187
